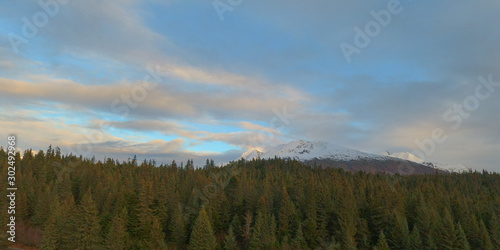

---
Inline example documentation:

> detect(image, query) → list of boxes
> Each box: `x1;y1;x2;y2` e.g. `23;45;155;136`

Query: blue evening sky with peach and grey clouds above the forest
0;0;500;172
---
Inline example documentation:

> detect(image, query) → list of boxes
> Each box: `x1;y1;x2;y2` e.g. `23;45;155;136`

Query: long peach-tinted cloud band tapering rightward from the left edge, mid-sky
0;78;300;122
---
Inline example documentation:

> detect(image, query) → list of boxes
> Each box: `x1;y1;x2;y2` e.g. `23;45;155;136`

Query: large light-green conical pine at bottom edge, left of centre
188;207;217;250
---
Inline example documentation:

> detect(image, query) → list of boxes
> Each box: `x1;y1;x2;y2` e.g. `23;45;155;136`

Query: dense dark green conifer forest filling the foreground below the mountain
0;148;500;249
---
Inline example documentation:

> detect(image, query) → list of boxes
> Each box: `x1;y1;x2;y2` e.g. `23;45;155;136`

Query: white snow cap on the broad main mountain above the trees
241;140;388;161
